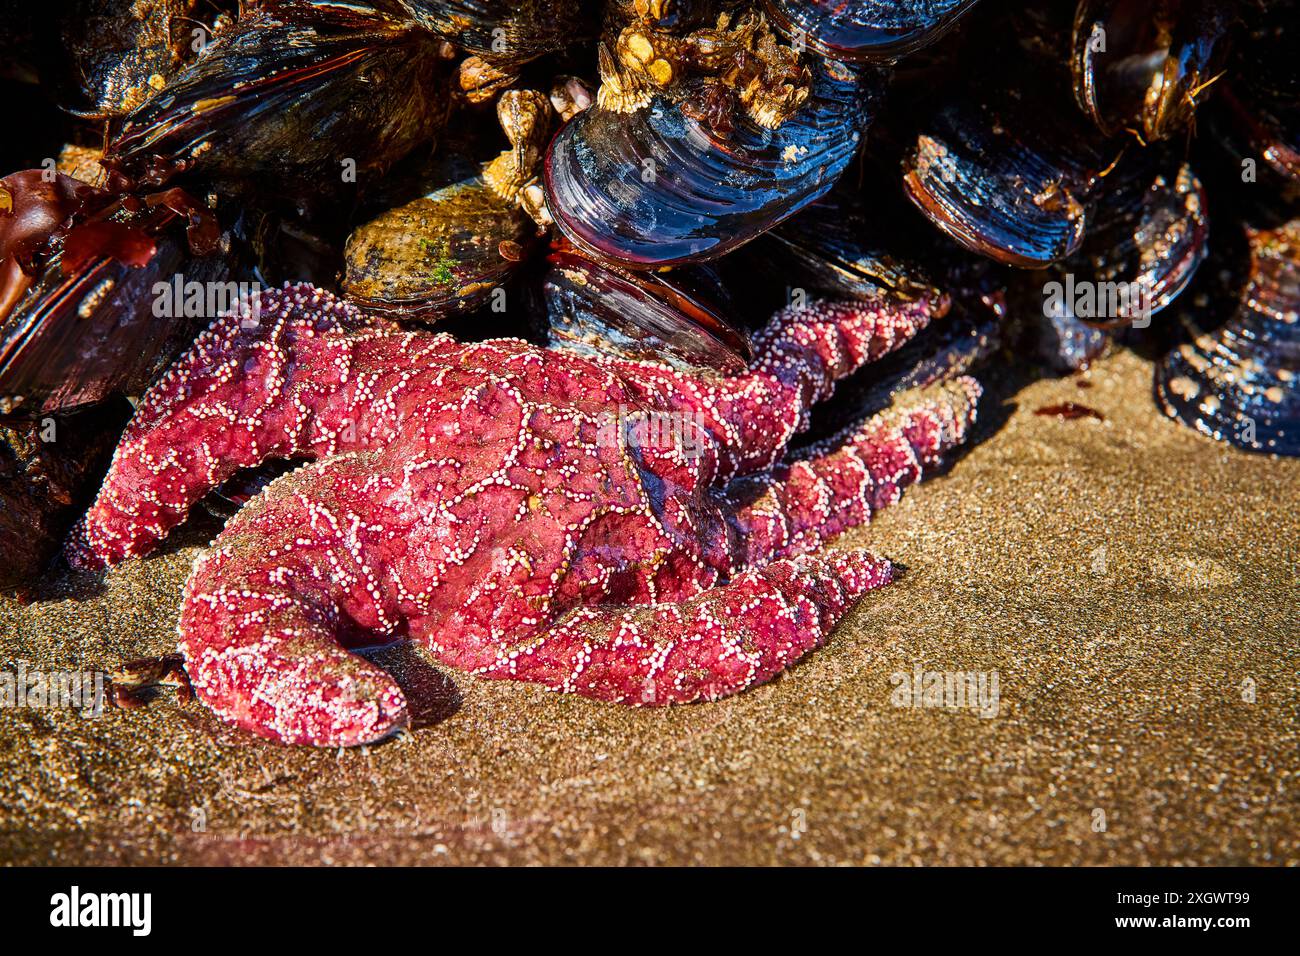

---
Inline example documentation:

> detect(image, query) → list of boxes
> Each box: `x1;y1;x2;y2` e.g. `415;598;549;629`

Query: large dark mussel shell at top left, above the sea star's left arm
105;4;450;196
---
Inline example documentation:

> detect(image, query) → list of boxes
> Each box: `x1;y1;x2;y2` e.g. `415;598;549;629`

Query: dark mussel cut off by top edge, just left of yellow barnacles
397;0;592;65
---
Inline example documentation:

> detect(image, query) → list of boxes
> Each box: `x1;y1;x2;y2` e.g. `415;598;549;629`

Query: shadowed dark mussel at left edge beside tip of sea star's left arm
0;399;131;591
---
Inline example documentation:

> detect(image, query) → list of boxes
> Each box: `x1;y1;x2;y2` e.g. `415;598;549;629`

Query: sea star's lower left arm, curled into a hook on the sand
179;453;407;747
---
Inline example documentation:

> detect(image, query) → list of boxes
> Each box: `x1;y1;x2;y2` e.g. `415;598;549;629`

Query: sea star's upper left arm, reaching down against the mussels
65;286;390;568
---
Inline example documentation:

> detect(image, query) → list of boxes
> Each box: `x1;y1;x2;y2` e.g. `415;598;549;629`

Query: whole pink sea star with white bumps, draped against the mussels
69;285;980;744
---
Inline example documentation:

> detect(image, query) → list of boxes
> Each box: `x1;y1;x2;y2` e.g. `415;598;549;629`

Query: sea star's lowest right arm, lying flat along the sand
465;550;891;705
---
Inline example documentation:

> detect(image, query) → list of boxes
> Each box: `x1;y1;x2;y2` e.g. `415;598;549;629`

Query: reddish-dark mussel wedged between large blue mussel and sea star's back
542;243;753;375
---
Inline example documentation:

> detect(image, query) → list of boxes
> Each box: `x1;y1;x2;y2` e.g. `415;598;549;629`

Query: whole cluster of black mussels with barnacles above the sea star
0;0;1300;588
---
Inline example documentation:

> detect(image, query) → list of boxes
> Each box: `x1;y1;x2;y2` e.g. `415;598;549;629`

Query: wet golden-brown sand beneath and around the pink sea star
0;354;1300;864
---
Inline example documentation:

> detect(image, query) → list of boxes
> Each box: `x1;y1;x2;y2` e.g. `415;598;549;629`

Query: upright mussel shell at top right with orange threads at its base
1071;0;1231;143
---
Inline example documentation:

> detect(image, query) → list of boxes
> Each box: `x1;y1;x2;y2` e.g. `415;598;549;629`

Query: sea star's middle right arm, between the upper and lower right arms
727;377;982;567
